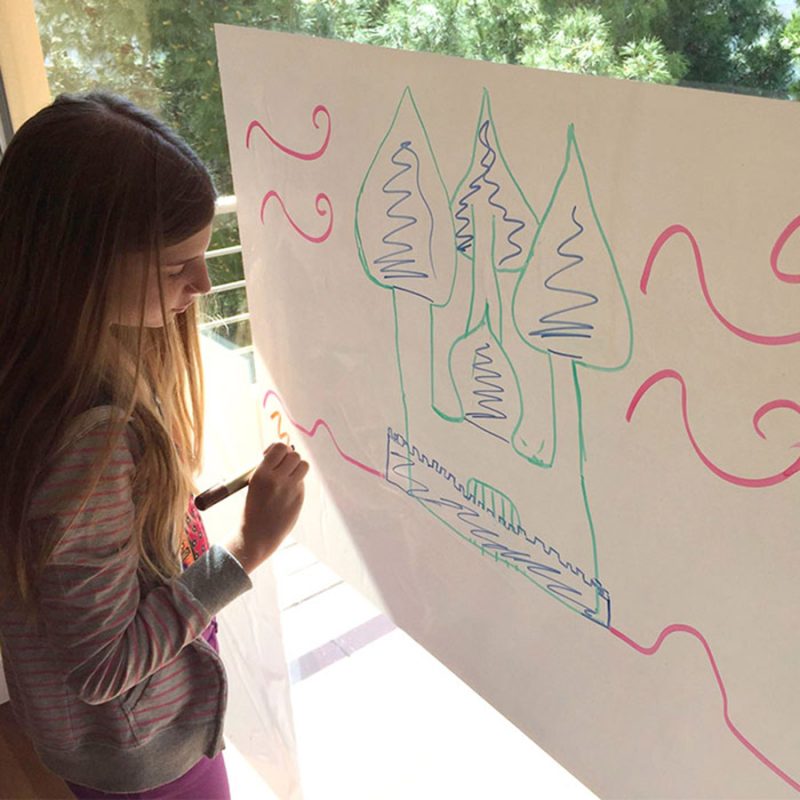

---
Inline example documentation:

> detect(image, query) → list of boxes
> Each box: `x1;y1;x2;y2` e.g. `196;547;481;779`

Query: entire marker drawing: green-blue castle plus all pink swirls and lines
228;34;800;790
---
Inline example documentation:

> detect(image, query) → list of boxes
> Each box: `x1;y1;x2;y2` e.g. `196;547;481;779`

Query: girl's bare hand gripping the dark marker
226;442;308;573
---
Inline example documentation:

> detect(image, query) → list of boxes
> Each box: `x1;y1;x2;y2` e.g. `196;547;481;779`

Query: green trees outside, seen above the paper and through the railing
36;0;800;340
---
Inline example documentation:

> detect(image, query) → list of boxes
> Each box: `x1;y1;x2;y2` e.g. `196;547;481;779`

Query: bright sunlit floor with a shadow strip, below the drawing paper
273;538;595;800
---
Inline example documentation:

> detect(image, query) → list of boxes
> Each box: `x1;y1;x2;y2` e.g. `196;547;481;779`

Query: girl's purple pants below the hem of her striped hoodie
66;620;231;800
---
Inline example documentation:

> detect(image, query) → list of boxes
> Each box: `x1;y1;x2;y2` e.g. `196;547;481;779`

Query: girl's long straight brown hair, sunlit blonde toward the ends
0;92;215;603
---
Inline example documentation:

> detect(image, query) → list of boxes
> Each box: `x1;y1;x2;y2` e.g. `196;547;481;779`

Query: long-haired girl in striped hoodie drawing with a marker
0;93;308;800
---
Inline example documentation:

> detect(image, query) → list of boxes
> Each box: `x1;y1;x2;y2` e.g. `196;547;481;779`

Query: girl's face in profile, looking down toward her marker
119;224;211;328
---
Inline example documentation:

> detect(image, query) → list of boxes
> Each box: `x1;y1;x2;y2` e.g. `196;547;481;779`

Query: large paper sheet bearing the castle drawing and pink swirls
217;26;800;798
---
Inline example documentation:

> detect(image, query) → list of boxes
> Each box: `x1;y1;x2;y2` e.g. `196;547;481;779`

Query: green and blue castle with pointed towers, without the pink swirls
355;88;633;626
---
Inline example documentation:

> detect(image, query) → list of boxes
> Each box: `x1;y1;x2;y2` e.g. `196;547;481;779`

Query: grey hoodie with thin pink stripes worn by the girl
0;406;252;792
